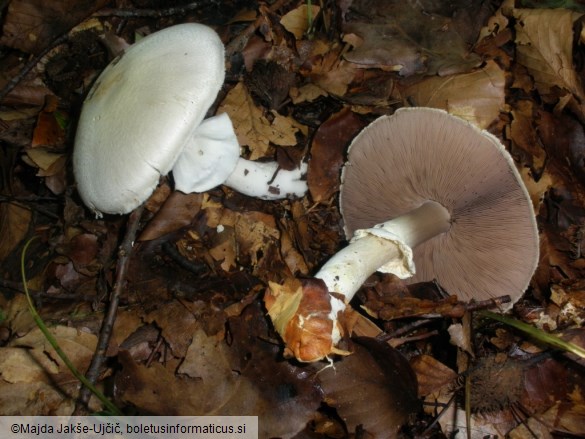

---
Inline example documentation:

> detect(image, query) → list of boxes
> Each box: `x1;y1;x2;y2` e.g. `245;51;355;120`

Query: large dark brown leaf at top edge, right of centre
343;0;487;76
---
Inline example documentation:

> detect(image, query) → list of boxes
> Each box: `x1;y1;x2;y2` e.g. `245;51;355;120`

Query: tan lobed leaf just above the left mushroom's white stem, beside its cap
218;82;299;160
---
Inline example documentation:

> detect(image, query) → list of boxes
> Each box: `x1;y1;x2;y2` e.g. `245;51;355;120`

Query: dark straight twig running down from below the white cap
75;206;144;415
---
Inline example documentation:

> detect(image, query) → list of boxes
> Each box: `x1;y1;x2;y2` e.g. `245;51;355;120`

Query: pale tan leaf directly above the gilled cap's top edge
402;61;506;129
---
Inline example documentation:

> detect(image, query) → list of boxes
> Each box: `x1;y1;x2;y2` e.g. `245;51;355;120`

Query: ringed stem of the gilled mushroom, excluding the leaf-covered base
315;201;451;303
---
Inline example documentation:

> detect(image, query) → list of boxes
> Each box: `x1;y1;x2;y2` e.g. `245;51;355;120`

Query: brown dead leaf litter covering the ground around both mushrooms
0;0;585;437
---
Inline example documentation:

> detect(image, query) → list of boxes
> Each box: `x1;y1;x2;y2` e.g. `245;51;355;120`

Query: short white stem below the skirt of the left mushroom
224;158;307;200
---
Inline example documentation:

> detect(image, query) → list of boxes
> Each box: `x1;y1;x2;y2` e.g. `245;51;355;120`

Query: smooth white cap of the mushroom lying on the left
73;23;225;214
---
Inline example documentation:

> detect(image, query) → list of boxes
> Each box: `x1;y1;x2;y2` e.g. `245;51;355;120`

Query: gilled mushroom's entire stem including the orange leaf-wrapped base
264;201;451;362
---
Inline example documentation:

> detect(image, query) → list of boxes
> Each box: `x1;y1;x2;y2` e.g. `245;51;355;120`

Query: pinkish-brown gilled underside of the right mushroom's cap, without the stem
340;108;539;303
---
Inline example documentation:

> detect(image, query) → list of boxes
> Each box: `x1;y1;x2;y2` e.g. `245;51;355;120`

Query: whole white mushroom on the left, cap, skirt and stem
73;23;307;216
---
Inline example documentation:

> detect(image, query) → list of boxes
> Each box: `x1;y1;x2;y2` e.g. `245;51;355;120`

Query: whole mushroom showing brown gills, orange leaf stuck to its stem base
265;108;539;361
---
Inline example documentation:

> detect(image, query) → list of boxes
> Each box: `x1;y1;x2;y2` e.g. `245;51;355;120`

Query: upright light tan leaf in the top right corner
514;9;585;114
